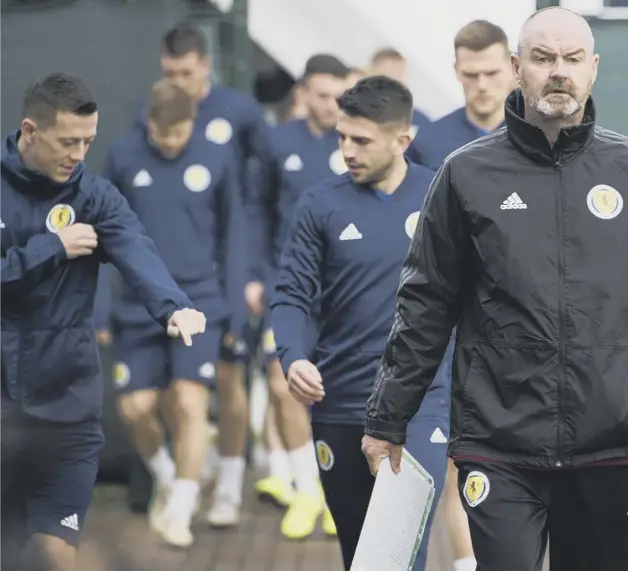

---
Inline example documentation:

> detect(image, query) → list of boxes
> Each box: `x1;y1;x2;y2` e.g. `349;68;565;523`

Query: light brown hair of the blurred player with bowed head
146;79;196;129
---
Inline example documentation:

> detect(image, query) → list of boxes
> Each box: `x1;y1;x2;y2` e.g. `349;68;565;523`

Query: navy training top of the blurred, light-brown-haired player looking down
99;125;247;334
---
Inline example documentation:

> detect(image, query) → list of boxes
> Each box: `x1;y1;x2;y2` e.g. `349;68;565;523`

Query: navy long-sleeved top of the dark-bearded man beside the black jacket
271;165;440;424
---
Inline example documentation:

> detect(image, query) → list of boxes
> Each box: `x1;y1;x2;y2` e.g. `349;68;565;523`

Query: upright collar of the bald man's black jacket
506;89;595;166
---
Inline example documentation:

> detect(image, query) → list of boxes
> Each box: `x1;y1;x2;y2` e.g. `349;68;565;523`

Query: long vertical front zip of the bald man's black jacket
554;155;566;468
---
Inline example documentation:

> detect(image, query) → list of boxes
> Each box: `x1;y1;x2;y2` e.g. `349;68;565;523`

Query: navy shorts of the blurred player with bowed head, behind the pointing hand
112;323;247;393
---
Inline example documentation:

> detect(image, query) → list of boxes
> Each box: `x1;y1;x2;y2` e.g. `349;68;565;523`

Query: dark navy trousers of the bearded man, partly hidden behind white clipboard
312;413;449;571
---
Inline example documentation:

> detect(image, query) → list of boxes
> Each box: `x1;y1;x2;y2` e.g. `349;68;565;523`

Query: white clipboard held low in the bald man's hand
351;448;435;571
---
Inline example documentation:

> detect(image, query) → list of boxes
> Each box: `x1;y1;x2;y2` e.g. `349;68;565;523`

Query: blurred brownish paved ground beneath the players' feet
79;481;452;571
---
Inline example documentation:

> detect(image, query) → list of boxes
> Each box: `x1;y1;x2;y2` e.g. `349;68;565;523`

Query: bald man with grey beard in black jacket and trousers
362;8;628;571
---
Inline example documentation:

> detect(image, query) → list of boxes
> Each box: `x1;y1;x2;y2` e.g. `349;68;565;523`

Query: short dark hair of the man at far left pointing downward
22;73;98;127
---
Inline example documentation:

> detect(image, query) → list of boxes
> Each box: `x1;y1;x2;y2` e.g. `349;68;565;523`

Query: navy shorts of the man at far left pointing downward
1;411;104;554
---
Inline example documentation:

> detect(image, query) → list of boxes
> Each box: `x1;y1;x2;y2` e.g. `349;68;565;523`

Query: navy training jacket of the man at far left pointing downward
0;132;192;422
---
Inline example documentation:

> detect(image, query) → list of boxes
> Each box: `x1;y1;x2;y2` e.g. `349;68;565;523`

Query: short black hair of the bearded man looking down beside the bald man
336;75;413;125
